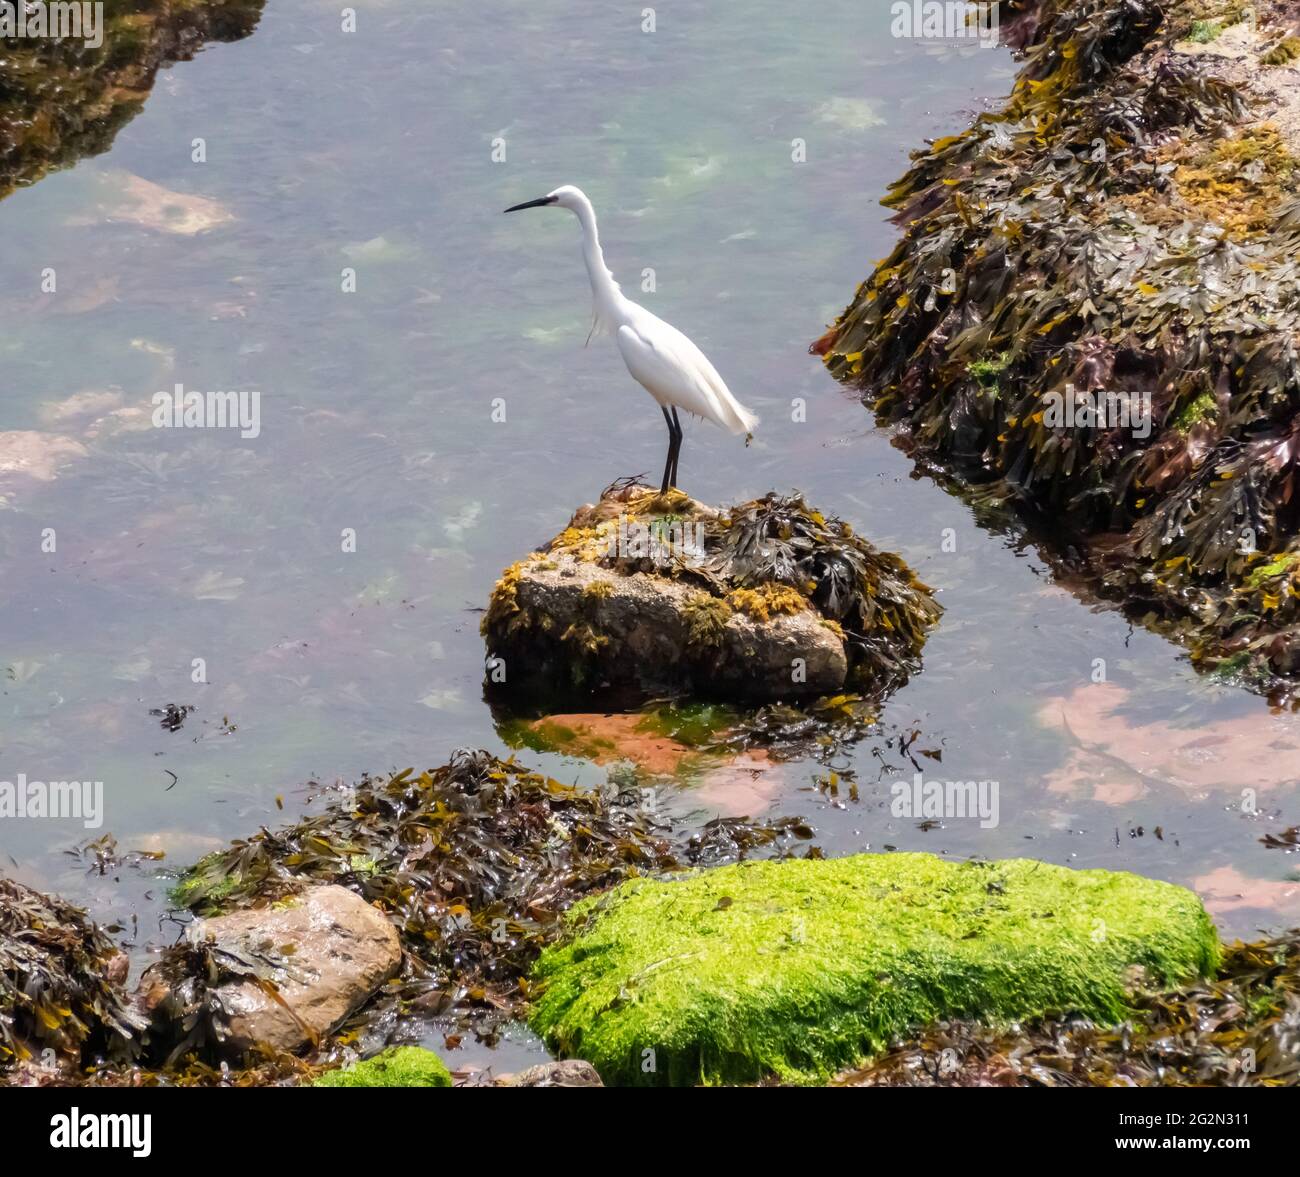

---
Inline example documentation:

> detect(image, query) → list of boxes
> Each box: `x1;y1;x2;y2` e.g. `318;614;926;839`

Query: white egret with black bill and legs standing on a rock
506;183;758;493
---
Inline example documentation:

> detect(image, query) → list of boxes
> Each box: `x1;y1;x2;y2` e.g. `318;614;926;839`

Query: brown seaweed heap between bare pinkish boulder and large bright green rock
152;752;807;1068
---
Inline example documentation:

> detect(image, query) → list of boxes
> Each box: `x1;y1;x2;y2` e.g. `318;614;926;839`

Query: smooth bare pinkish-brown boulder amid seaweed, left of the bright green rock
147;884;402;1056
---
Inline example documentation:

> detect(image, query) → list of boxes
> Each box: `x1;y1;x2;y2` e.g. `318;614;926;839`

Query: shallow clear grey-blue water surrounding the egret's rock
0;0;1300;1053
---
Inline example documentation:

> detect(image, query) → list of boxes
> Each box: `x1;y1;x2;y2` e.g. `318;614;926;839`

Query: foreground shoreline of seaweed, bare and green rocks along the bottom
0;753;1300;1087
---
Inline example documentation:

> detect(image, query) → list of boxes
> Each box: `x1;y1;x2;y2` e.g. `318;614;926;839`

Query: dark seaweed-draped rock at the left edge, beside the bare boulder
0;879;143;1078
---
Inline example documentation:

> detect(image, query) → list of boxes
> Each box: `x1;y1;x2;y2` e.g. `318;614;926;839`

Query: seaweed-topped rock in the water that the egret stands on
481;484;940;698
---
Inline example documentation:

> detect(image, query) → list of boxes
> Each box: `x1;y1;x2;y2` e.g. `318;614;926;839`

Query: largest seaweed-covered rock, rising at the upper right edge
813;0;1300;694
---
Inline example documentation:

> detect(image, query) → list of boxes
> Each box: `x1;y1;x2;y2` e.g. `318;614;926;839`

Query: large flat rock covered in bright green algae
530;854;1219;1086
